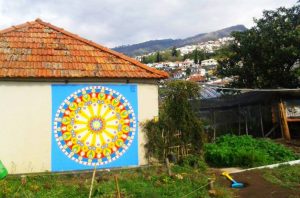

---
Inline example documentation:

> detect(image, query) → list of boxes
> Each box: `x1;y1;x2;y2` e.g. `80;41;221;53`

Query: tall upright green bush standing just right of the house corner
160;81;203;150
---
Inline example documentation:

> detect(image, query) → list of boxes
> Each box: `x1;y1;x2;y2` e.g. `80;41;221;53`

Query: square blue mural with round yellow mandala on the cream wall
52;85;138;171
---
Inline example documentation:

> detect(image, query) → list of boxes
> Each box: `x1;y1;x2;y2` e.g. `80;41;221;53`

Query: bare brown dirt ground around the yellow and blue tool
217;170;300;198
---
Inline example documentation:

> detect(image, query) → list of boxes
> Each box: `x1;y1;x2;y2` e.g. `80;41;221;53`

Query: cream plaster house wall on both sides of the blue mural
0;82;158;174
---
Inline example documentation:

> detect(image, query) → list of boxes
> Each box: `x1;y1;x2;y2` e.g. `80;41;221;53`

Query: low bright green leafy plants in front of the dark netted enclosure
204;135;299;167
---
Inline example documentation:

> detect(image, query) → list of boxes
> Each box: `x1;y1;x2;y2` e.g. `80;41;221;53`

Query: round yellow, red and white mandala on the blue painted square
54;86;136;166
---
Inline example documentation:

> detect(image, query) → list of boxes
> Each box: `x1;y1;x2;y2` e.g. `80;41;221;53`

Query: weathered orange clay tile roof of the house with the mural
0;19;168;79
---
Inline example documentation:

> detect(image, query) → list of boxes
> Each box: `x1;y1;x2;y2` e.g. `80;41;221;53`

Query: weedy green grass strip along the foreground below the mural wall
0;165;232;198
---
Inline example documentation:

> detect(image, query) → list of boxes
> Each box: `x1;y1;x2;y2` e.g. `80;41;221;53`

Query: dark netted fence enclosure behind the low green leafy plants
192;91;300;139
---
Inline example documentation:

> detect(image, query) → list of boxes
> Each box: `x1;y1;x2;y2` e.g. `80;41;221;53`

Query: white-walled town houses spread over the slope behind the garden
135;37;234;85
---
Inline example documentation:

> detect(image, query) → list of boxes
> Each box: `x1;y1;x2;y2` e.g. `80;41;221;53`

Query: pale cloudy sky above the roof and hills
0;0;297;47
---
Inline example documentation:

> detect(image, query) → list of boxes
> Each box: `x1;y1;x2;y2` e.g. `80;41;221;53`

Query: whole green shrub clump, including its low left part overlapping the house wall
143;81;203;159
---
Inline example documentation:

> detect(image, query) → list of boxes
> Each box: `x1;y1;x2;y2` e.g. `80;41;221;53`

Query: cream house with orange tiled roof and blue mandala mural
0;19;168;174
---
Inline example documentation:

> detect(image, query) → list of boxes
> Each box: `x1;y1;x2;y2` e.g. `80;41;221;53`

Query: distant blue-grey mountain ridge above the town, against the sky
113;25;247;56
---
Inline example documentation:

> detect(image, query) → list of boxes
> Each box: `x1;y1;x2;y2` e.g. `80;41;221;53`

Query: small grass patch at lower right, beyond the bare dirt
263;165;300;190
